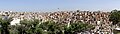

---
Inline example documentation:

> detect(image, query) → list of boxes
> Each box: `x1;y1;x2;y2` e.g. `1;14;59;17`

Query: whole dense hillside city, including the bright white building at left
0;10;120;34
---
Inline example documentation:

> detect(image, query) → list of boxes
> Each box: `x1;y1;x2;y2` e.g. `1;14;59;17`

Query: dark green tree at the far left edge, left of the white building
0;17;12;34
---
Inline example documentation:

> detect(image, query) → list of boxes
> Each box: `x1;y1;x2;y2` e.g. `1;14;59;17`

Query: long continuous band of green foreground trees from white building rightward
10;19;92;34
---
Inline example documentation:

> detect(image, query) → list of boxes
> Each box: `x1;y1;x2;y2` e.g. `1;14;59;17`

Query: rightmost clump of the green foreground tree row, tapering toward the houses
65;22;94;34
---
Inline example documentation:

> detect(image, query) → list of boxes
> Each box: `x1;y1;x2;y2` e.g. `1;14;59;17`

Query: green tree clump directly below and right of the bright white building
11;19;43;34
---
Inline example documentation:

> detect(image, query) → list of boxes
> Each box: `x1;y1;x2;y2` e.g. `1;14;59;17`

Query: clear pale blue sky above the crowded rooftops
0;0;120;11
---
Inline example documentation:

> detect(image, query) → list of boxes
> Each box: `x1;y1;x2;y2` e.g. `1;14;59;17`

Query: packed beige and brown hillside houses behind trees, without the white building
0;10;118;34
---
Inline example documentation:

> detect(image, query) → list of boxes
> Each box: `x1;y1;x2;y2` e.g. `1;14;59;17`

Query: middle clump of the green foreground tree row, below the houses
39;21;64;34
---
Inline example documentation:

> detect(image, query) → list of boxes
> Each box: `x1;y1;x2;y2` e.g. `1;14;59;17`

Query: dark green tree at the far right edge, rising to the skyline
109;10;120;25
